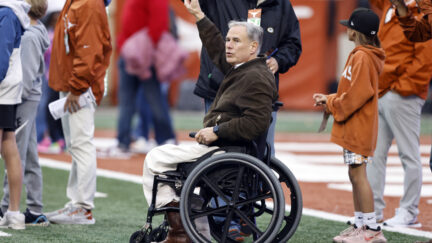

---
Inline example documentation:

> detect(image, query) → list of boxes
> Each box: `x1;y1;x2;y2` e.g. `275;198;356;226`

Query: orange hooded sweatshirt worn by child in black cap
327;46;385;156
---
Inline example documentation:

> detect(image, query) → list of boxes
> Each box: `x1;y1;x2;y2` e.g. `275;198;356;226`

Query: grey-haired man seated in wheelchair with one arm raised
143;0;277;242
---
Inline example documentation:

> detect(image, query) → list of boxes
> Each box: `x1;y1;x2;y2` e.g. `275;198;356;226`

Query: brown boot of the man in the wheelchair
160;202;192;243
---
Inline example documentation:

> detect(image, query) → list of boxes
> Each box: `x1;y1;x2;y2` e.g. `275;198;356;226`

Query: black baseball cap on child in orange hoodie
340;8;379;37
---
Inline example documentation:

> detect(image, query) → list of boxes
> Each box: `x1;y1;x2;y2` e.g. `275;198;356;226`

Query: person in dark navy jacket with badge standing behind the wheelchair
194;0;302;155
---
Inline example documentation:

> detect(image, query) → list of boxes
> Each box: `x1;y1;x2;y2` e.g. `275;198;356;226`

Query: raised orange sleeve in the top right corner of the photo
390;0;432;42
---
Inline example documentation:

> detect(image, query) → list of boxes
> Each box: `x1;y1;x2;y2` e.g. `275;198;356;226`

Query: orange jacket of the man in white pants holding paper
49;0;112;104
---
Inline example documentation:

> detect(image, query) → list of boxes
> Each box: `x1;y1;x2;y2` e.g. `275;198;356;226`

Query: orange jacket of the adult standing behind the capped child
370;0;432;99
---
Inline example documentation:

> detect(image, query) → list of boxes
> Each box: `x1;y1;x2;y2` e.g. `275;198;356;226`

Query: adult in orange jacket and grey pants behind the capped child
367;0;432;227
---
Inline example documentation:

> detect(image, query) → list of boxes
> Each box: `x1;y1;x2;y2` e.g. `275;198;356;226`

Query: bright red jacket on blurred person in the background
117;0;169;51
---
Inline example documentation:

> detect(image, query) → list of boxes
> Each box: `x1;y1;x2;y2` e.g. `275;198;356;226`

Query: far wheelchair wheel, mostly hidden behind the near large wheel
267;158;303;243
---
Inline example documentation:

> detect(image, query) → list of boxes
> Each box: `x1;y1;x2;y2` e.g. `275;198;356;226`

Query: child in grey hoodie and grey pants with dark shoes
1;0;50;226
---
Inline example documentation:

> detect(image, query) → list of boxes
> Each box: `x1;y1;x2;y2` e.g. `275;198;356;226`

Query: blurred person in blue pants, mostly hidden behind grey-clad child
36;0;66;154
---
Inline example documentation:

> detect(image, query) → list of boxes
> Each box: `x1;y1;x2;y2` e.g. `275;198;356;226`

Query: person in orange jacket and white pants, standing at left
45;0;111;224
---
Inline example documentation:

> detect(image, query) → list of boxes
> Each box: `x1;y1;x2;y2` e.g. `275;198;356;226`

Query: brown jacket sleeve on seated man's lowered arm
218;77;274;141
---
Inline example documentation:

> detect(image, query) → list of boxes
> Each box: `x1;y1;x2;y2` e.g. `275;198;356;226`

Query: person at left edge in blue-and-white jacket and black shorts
0;0;30;229
